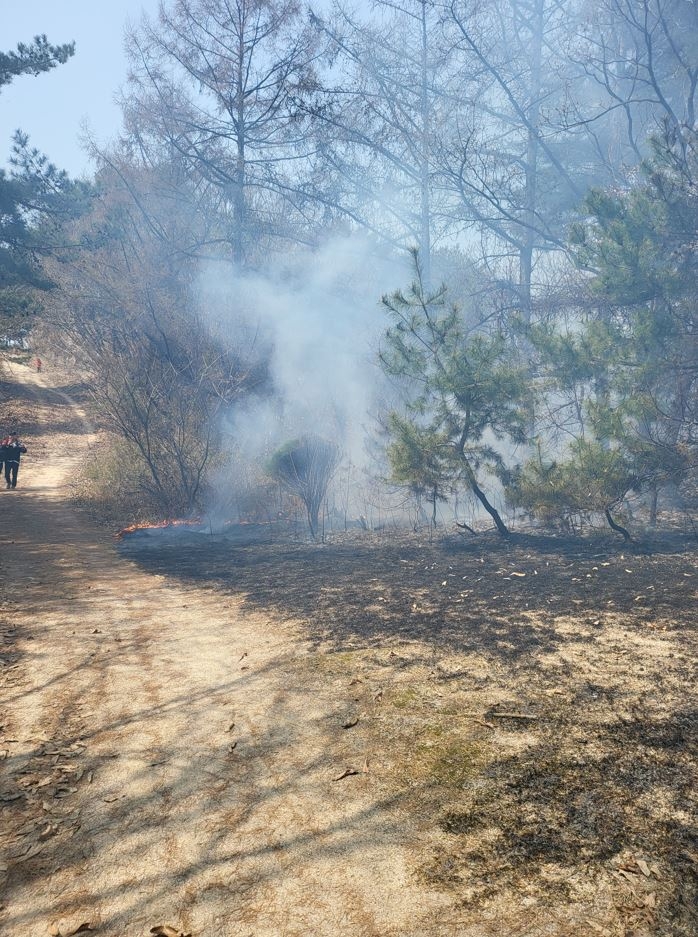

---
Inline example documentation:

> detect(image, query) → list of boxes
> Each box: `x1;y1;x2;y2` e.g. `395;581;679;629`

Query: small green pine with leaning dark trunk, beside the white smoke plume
380;252;528;536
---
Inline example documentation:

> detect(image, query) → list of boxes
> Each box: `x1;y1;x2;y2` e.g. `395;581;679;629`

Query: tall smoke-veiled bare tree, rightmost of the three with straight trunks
440;0;588;320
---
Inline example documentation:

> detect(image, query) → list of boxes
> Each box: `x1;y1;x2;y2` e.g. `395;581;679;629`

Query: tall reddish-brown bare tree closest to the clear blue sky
124;0;315;264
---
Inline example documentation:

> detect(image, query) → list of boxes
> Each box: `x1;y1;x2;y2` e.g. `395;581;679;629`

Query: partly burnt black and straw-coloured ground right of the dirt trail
121;532;698;937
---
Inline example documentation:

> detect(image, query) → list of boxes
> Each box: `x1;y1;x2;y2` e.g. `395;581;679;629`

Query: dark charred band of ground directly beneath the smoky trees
120;530;698;665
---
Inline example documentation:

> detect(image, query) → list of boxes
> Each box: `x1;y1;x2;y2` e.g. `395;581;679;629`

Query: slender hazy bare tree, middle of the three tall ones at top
312;0;453;279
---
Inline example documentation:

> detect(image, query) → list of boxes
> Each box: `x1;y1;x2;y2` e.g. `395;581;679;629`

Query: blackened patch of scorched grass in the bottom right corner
430;709;698;935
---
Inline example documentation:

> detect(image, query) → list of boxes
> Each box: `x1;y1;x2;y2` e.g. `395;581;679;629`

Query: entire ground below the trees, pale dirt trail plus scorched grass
0;354;698;937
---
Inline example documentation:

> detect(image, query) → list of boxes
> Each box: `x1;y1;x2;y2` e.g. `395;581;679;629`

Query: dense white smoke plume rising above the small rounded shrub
198;235;402;465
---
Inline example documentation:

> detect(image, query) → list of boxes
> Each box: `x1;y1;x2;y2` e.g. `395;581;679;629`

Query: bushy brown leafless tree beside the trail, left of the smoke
41;157;265;516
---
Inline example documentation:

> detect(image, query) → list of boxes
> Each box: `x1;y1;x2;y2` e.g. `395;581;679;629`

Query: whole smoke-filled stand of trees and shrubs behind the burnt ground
0;0;698;537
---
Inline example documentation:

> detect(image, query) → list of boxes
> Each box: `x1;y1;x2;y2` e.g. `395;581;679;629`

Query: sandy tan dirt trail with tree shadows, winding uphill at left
0;366;444;937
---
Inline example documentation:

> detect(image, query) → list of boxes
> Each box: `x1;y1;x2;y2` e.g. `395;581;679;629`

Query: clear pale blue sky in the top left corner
0;0;158;176
